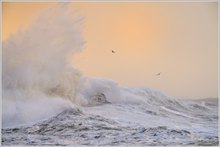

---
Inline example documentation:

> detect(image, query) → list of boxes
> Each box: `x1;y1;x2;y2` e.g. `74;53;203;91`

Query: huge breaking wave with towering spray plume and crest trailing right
2;4;217;127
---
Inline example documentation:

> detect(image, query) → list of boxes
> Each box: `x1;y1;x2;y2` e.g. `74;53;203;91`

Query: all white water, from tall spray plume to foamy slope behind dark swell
3;5;217;146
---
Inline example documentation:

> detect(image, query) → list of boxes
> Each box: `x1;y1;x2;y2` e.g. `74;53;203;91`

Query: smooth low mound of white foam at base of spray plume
2;97;75;128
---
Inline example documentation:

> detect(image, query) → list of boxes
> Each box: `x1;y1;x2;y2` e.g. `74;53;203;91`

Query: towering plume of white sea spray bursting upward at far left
2;4;85;127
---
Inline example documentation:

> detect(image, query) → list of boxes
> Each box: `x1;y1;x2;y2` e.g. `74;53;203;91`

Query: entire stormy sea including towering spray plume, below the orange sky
2;5;219;146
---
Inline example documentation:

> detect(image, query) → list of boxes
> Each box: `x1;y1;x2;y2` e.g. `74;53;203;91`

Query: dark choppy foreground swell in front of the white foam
2;104;219;146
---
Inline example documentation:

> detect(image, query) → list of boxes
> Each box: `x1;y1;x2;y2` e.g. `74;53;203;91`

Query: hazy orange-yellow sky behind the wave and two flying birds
2;2;218;99
